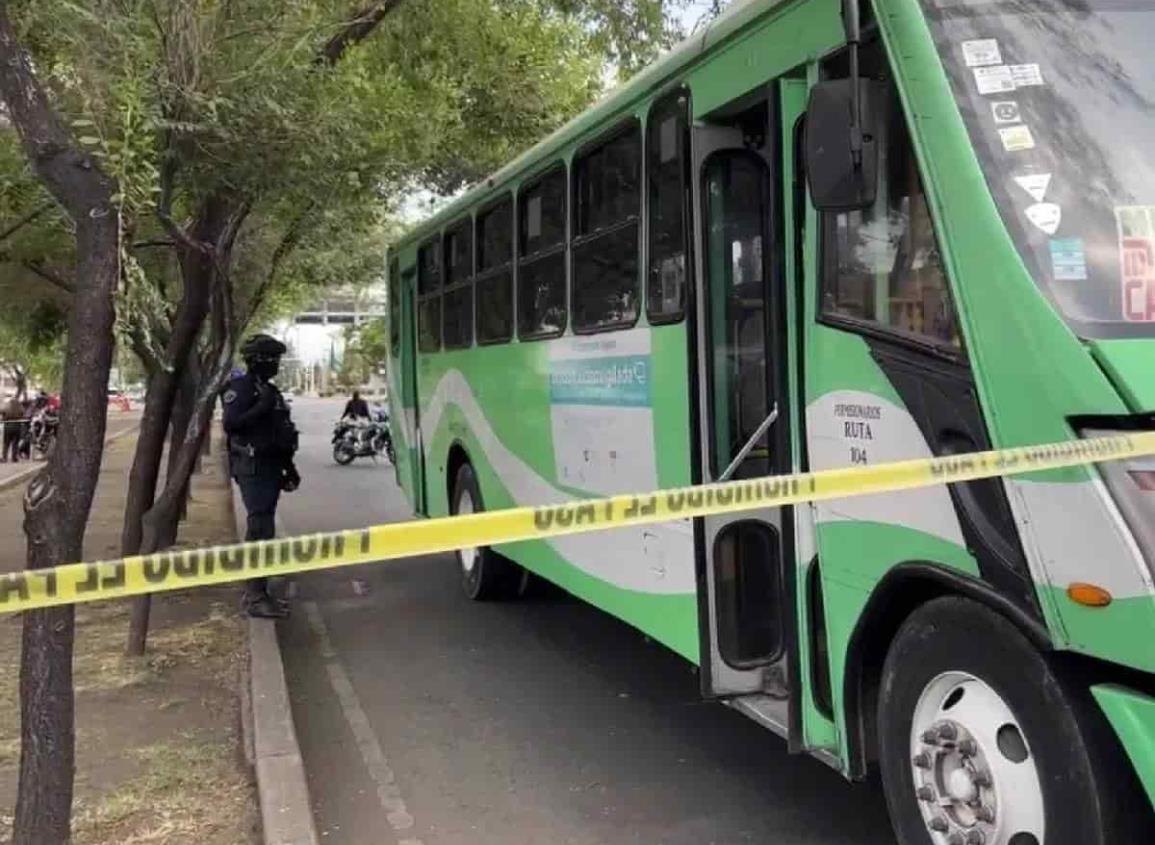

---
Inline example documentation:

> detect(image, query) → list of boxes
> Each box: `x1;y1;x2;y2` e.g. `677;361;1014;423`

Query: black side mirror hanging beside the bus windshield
806;80;878;211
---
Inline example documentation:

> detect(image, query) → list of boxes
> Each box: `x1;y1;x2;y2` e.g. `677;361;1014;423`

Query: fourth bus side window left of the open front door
477;199;513;344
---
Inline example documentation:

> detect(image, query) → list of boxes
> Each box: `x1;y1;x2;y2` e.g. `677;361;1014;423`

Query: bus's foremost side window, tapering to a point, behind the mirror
821;76;962;350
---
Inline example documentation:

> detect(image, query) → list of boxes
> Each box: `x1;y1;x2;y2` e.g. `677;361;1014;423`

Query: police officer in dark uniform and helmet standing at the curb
222;335;300;619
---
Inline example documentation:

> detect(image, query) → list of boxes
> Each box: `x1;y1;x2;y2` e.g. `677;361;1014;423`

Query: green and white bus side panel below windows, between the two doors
420;327;698;661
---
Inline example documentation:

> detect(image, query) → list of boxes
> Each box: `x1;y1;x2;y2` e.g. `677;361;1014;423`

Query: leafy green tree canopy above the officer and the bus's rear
0;0;686;376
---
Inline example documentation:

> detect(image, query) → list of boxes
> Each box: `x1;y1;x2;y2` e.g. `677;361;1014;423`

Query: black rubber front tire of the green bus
877;597;1149;845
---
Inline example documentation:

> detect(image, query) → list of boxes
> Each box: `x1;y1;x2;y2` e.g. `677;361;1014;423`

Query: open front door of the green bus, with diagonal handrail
693;98;790;733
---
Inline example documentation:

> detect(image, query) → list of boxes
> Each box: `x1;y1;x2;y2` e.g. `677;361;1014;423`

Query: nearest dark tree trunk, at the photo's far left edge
0;0;120;845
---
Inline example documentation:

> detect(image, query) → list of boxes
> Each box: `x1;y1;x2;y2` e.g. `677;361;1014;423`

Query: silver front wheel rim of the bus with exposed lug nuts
910;672;1045;845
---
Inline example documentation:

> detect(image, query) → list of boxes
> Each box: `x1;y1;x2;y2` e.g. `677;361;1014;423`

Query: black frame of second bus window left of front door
567;115;647;335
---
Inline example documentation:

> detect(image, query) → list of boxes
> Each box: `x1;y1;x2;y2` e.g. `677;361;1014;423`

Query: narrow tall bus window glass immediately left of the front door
646;91;688;323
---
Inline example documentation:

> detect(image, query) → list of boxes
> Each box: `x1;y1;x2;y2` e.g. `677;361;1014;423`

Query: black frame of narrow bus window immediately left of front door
641;84;695;326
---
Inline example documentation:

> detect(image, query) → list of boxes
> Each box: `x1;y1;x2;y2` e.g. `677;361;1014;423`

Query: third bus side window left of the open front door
517;165;567;341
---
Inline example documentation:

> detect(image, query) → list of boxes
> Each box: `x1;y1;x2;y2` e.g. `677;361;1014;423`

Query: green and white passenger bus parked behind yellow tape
388;0;1155;845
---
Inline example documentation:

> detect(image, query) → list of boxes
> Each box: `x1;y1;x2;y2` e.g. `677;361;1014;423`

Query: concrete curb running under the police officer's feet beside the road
232;483;319;845
